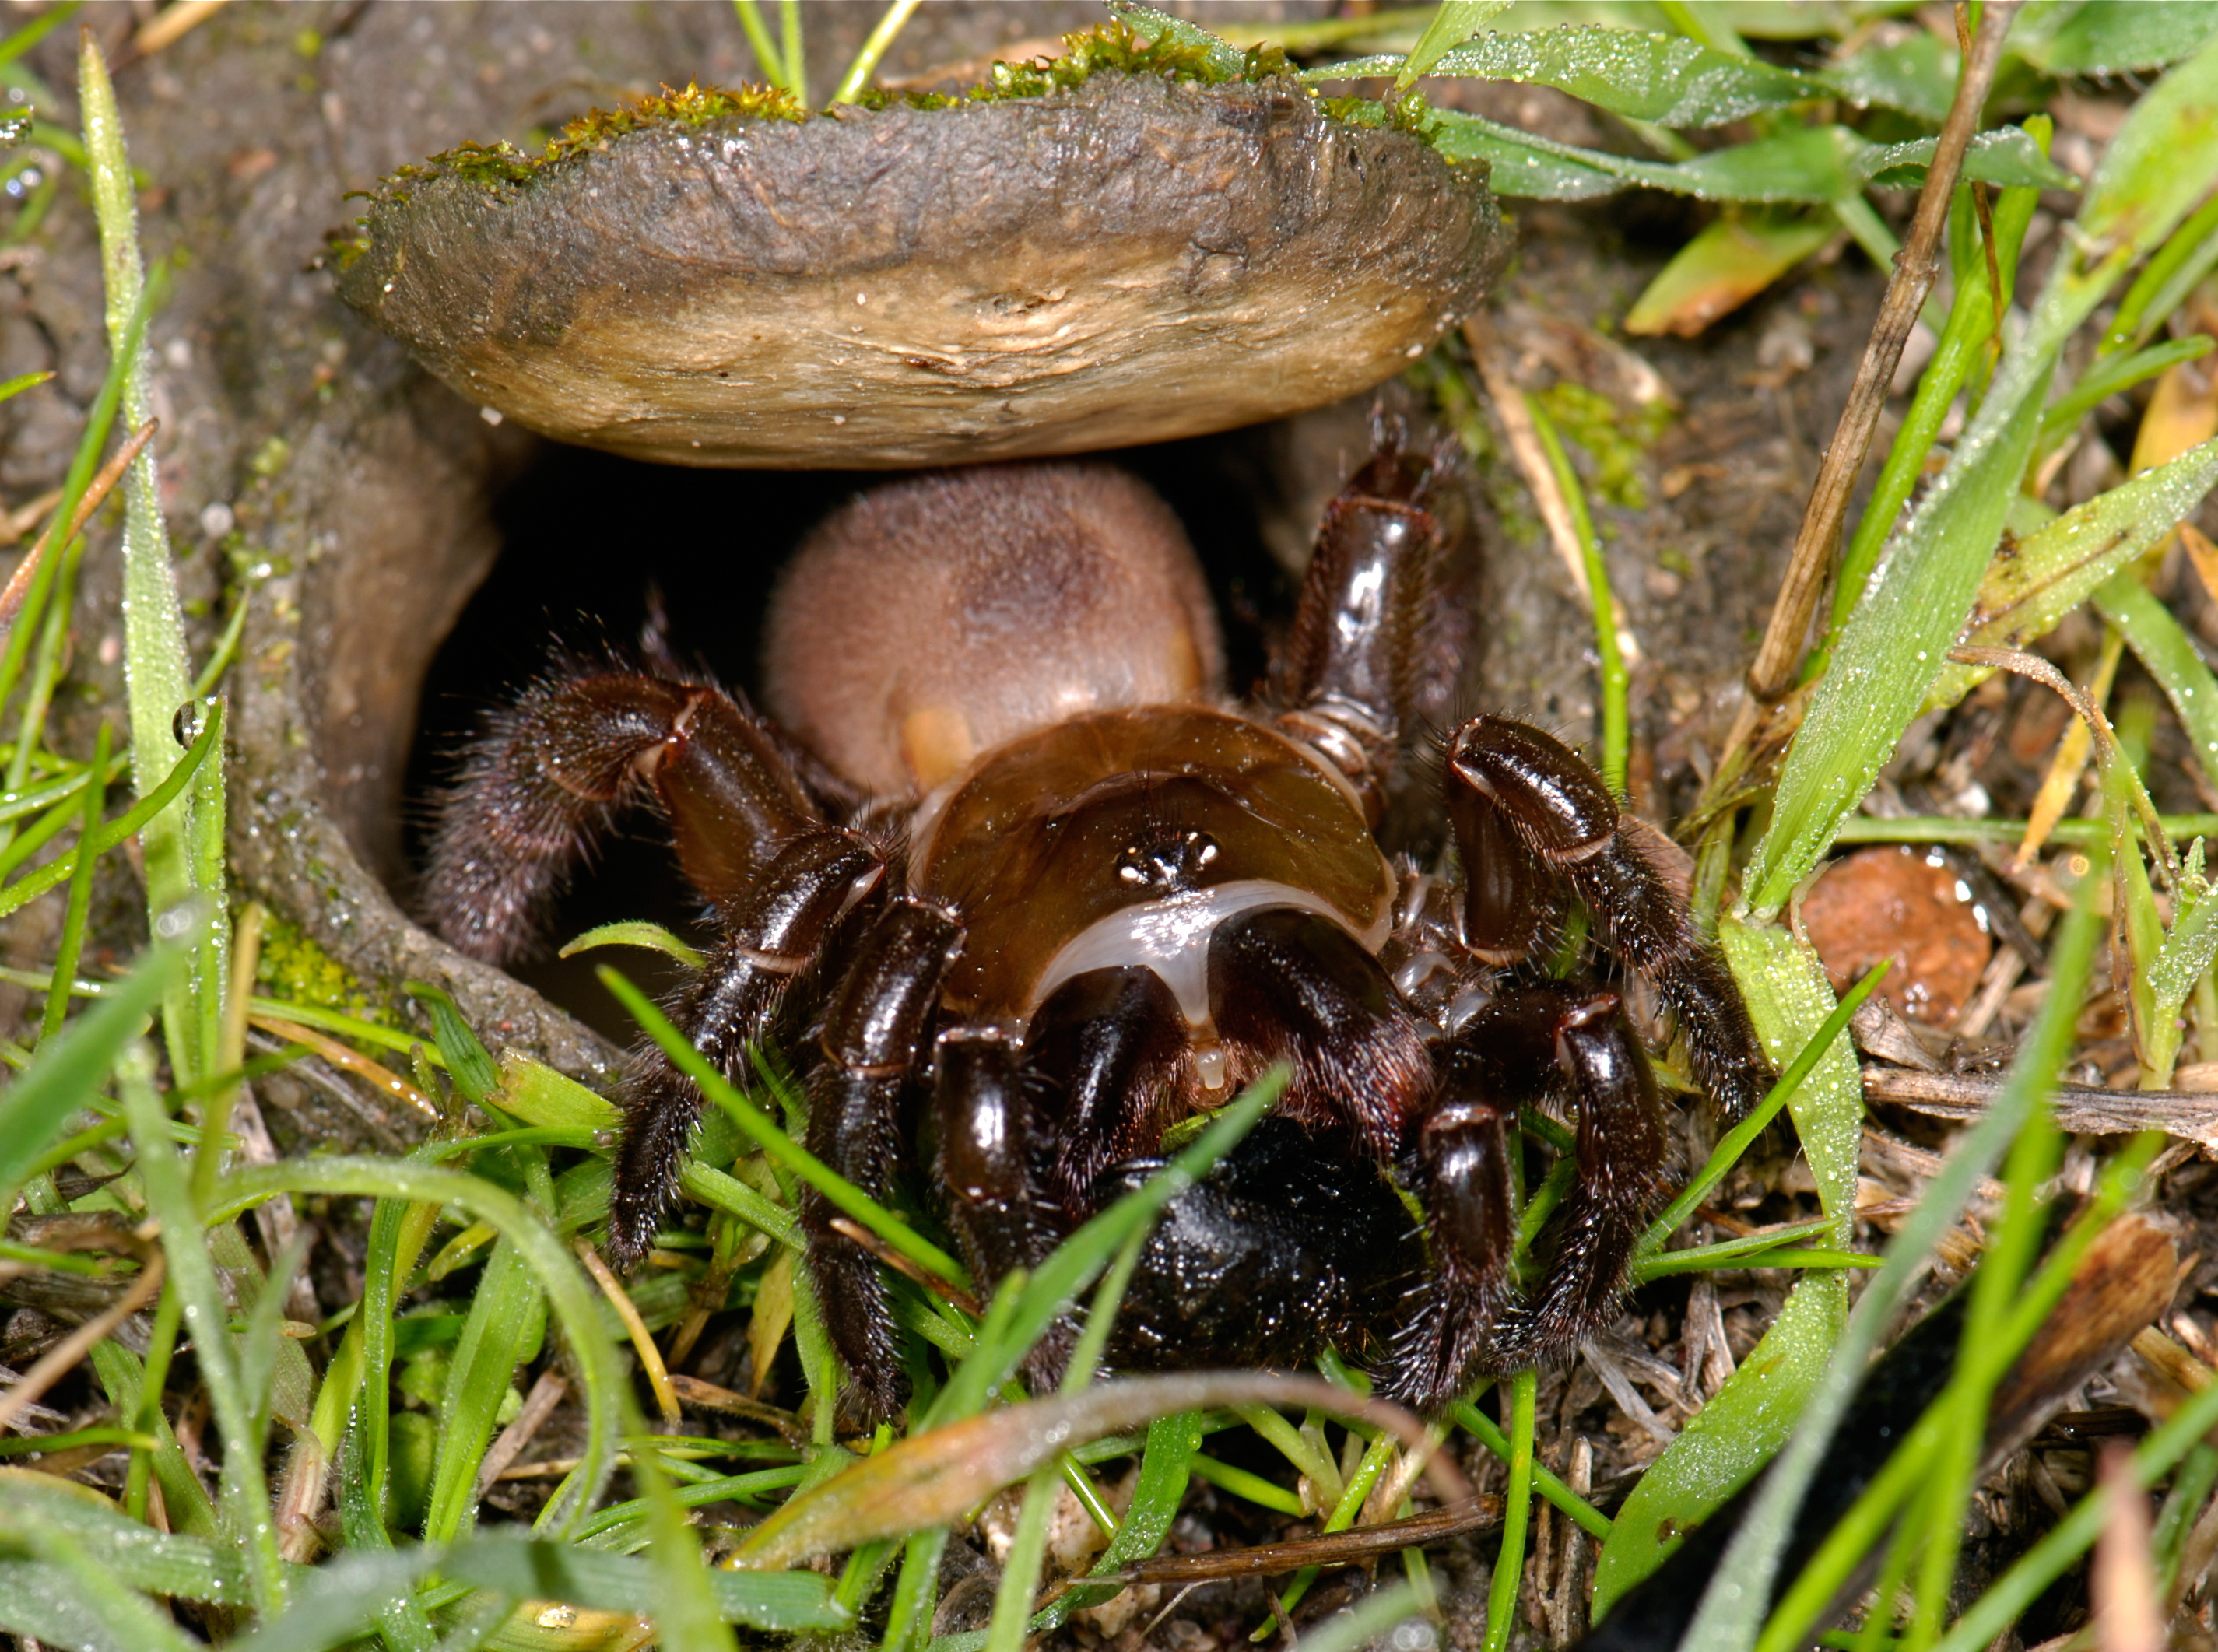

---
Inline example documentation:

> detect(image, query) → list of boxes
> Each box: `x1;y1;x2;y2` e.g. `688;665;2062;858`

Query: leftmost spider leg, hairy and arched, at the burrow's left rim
423;672;821;963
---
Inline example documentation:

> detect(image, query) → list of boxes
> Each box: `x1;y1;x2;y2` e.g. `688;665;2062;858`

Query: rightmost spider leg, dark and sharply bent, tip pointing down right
1448;716;1772;1117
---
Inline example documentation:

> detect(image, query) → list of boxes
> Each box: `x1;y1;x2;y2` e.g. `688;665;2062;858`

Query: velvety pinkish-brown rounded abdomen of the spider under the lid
765;464;1224;796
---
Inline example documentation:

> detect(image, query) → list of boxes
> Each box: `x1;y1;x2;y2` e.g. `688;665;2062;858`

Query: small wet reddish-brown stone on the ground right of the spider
1801;845;1994;1026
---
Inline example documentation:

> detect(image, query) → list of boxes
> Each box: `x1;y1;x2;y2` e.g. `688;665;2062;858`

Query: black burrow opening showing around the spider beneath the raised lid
399;414;1368;1042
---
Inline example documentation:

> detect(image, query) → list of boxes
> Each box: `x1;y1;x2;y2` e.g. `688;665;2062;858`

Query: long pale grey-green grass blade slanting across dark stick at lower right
1681;876;2103;1652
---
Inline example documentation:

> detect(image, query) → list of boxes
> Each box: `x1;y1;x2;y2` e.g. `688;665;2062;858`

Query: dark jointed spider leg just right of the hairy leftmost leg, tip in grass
608;830;885;1268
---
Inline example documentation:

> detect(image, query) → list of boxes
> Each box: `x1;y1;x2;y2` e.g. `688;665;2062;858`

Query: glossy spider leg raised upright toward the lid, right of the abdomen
1278;437;1442;825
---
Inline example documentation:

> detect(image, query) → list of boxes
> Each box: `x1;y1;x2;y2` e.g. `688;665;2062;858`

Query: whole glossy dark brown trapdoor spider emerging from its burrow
428;437;1770;1417
